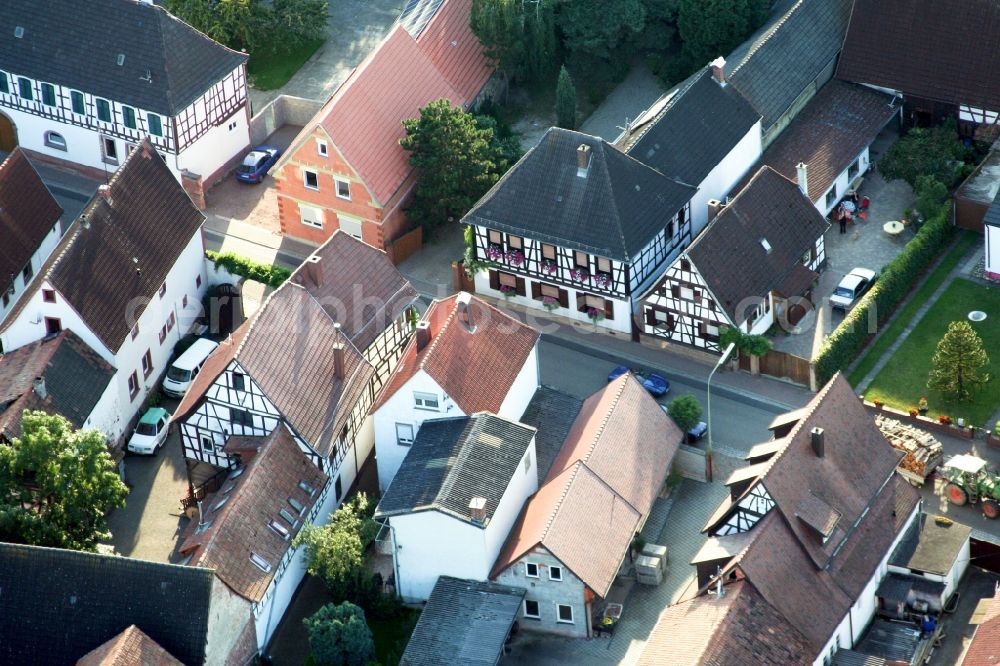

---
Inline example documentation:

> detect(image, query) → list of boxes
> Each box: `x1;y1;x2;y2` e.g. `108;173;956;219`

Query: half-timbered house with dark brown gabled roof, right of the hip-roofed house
642;166;830;352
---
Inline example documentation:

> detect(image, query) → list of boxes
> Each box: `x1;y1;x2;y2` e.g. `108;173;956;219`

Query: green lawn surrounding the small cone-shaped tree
865;279;1000;427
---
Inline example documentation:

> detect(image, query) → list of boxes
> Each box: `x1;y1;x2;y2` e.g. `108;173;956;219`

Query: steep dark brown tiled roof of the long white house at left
1;139;205;353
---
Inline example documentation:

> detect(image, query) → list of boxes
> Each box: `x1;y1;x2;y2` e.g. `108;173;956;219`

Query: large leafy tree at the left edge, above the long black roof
0;410;128;551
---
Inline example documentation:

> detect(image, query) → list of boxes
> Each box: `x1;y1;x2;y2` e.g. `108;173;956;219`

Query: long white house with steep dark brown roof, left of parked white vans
0;141;206;437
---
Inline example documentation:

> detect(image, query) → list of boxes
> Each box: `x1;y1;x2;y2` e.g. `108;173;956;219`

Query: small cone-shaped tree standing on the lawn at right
927;321;990;400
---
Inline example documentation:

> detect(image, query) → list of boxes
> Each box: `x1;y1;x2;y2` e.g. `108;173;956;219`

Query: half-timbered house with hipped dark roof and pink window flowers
462;127;697;333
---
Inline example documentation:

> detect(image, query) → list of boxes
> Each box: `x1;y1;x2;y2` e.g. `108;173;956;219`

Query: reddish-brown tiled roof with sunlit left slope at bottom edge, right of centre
638;581;812;666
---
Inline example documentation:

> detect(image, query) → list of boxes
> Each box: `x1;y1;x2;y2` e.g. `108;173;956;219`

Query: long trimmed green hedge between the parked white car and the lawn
815;206;955;386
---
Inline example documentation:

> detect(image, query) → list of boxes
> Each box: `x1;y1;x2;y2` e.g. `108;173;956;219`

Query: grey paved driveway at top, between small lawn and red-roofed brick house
250;0;403;113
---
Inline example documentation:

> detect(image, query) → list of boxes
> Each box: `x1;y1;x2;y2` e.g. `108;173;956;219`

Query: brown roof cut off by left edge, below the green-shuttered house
0;150;63;294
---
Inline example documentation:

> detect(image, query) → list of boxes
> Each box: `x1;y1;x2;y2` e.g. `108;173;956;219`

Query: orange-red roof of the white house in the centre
372;294;539;414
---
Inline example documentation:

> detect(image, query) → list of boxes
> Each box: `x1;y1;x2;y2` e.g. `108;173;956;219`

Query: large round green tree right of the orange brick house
399;99;509;230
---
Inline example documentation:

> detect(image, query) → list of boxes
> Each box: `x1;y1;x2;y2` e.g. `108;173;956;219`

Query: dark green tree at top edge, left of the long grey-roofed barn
677;0;771;66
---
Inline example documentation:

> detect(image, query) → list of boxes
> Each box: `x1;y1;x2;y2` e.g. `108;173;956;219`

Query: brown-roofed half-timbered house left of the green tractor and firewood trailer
676;375;921;666
